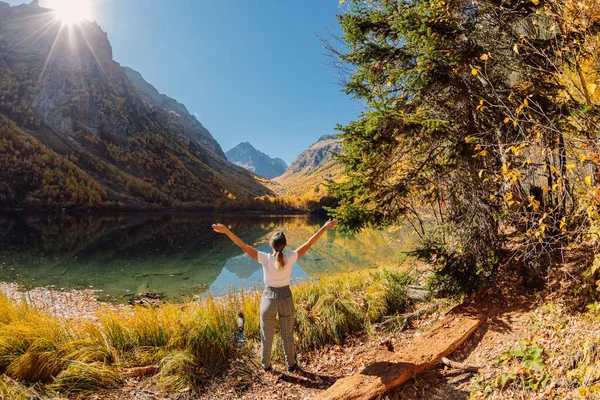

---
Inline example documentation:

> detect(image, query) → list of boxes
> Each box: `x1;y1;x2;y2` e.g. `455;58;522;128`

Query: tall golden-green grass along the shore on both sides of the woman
0;269;410;394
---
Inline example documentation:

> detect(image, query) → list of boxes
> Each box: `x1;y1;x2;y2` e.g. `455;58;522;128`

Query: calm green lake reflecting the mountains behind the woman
0;213;414;301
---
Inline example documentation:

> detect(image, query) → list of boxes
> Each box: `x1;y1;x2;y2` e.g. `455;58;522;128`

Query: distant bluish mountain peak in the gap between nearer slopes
226;142;287;179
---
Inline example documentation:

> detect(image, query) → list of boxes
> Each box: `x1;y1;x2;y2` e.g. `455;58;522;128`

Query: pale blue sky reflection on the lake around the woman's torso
208;244;309;295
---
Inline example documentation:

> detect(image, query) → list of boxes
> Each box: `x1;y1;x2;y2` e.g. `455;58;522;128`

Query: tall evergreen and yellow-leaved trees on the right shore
331;0;600;290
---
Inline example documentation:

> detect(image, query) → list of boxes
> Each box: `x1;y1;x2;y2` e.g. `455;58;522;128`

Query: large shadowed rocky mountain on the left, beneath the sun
0;2;269;208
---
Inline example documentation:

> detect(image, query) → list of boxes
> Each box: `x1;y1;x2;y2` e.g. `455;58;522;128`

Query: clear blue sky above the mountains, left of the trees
9;0;360;163
